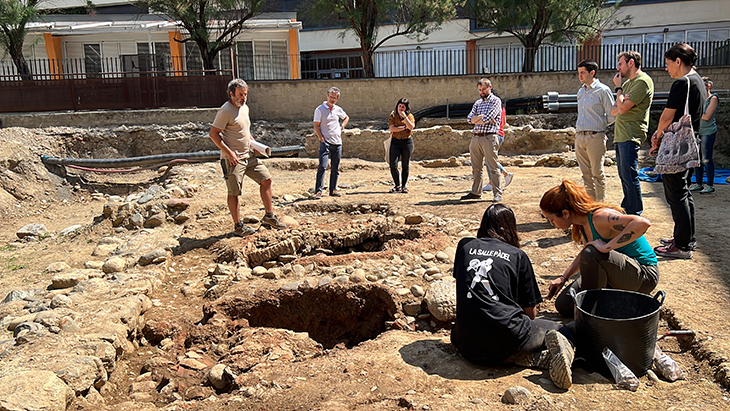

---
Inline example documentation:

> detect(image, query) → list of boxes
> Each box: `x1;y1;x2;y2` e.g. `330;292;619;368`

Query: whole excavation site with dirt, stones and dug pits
0;116;730;411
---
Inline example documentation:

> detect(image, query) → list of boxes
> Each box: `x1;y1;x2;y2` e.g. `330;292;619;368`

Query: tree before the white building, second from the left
140;0;266;70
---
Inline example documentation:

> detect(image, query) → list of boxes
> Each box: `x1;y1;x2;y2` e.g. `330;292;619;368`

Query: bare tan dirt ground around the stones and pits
0;134;730;410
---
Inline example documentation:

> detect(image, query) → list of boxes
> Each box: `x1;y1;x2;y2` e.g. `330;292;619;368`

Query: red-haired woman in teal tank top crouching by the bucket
540;180;659;318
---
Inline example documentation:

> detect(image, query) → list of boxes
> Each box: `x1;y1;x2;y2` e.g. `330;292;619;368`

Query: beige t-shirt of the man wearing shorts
213;101;251;160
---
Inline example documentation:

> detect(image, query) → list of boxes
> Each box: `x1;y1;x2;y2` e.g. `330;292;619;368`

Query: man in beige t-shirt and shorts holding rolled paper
210;79;286;237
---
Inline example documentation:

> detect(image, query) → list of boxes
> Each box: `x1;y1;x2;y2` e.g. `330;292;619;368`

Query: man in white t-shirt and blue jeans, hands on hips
314;87;350;199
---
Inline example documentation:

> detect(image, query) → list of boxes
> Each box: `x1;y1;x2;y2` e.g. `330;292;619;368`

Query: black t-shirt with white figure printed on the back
451;238;542;364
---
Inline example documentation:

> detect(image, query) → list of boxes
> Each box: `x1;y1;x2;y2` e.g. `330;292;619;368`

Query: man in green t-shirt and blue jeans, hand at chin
611;51;654;215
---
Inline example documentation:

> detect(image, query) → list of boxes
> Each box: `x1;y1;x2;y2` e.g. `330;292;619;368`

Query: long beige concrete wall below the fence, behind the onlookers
249;67;730;121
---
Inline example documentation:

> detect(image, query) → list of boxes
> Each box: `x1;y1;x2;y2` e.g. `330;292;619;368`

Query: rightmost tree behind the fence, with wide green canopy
469;0;631;72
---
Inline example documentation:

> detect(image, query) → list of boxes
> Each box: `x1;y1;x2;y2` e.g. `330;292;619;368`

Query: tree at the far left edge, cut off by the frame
0;0;39;78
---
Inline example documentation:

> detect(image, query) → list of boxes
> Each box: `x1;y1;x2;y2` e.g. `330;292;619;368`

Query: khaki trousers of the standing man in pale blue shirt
575;132;606;202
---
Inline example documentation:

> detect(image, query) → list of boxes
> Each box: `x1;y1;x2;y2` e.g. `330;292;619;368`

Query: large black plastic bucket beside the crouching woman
571;289;666;377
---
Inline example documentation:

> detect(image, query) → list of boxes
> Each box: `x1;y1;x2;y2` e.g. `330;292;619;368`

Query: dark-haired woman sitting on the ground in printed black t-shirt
451;204;574;388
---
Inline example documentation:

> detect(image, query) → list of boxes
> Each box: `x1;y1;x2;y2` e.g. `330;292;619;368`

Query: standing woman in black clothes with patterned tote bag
651;43;707;259
